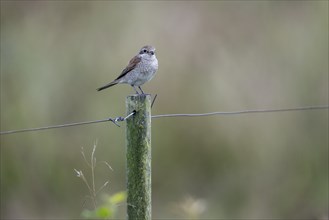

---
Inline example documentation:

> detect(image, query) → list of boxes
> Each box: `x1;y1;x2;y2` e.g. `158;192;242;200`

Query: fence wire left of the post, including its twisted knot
0;111;136;135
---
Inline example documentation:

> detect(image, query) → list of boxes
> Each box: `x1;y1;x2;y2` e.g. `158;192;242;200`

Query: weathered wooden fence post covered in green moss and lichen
126;94;151;220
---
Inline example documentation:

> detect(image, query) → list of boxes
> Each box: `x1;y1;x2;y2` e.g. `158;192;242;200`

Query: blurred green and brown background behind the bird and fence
0;1;328;219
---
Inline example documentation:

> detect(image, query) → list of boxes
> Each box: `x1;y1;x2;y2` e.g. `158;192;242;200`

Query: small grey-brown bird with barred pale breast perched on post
97;45;158;94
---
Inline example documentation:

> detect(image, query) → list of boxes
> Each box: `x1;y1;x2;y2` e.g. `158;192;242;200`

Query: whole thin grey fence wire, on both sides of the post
0;105;329;135
